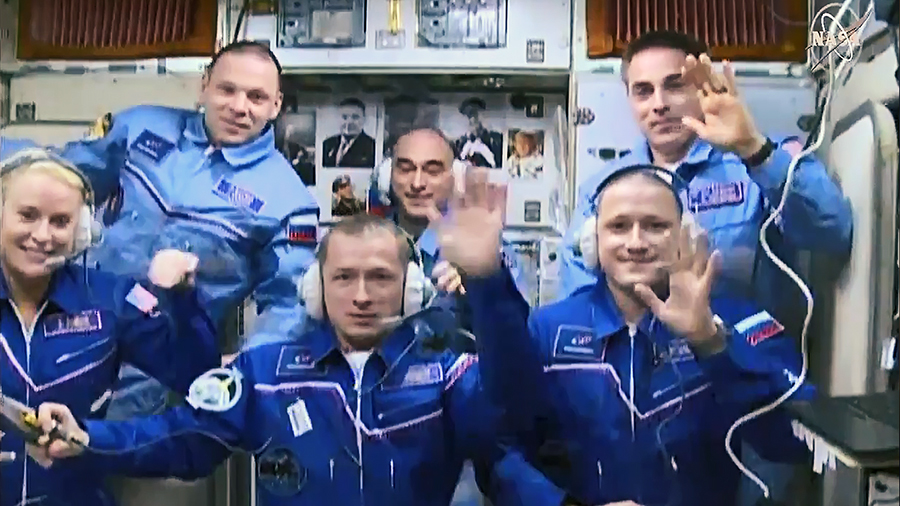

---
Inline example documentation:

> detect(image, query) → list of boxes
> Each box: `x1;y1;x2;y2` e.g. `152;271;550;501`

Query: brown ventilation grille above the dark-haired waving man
587;0;808;61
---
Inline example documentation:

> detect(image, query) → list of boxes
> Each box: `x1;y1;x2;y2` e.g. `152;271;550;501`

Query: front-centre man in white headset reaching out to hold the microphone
33;211;545;506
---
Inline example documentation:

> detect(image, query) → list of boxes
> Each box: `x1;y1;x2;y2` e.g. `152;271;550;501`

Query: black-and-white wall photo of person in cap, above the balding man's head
441;95;509;169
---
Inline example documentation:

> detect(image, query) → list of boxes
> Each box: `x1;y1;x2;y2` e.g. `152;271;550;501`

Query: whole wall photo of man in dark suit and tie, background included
317;96;380;169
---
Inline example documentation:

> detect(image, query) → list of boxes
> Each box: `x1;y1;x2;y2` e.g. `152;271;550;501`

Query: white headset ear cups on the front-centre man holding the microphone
297;241;435;321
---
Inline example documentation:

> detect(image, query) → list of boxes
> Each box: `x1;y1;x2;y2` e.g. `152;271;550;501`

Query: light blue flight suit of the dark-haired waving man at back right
560;138;853;324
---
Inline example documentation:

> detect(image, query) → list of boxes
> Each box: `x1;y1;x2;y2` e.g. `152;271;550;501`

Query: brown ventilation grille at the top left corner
18;0;217;60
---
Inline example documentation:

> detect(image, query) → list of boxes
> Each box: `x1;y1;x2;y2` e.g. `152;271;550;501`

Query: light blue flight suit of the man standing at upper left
62;106;318;418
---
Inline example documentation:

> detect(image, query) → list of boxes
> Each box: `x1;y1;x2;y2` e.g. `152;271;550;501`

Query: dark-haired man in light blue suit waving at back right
560;32;853;504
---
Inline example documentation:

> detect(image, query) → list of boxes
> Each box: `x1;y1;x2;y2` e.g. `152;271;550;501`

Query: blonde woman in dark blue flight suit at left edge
0;149;219;506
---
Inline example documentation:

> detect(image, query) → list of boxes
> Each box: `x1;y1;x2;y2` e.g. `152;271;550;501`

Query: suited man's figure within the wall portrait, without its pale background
322;97;375;169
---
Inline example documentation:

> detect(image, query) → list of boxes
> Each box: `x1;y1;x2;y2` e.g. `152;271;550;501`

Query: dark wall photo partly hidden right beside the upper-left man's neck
275;105;316;186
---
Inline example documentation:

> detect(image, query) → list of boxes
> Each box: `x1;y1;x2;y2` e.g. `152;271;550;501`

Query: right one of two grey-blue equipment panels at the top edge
418;0;506;48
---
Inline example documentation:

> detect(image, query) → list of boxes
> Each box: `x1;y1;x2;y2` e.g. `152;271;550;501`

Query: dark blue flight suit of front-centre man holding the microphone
79;308;528;506
